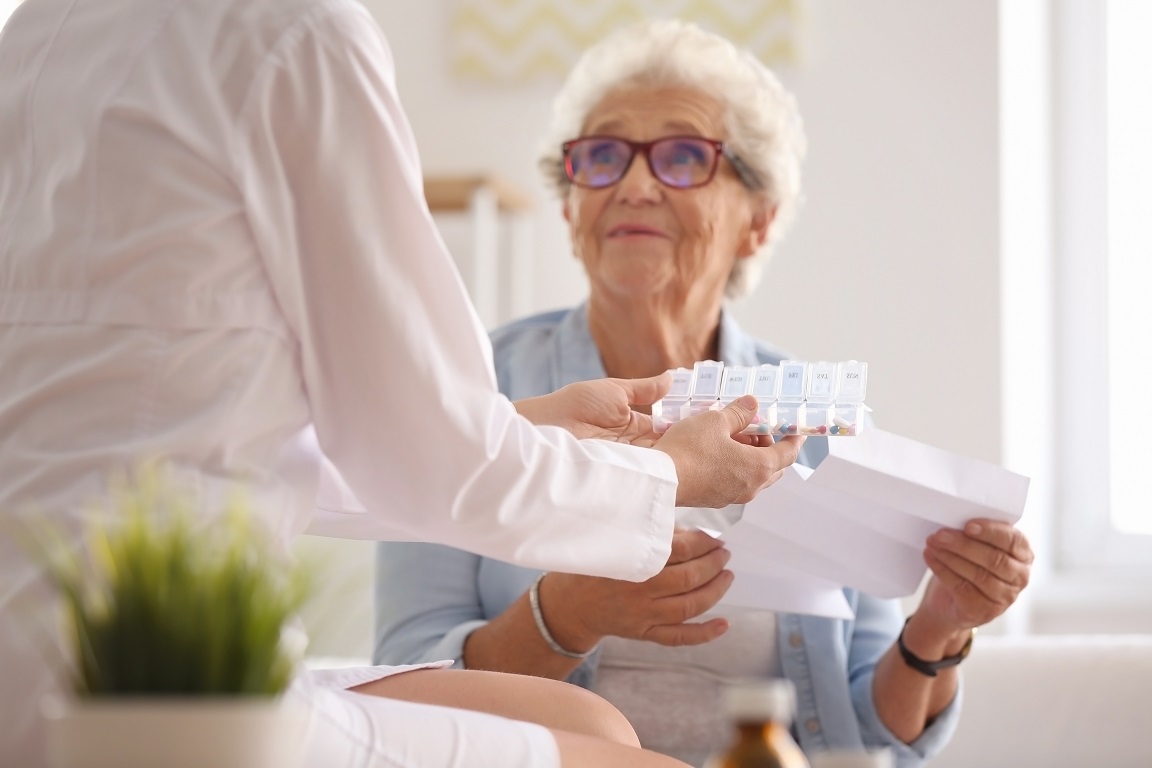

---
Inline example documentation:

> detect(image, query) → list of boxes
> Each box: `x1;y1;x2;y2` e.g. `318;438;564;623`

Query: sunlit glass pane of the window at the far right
1105;0;1152;534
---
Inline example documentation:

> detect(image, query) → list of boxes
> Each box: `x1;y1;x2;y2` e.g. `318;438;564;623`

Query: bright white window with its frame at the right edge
1053;0;1152;570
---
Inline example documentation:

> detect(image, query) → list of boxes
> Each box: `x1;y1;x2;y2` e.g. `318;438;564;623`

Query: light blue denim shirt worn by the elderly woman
374;305;961;768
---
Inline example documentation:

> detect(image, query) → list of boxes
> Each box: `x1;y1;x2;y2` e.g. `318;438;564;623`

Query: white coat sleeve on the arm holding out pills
236;0;676;580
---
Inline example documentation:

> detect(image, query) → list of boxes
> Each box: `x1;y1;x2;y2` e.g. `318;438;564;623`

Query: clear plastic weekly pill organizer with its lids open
652;360;872;438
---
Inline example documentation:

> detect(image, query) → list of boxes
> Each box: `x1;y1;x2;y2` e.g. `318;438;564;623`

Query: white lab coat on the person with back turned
0;0;676;767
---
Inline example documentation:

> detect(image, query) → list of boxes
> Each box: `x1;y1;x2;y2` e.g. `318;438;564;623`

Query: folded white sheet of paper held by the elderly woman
728;429;1029;598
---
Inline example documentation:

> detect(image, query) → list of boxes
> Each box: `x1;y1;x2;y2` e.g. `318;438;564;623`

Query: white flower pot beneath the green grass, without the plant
41;697;308;768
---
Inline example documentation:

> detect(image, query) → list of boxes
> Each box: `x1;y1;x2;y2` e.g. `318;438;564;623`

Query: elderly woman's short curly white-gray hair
538;20;808;298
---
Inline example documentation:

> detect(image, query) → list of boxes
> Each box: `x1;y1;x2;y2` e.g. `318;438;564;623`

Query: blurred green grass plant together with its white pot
37;467;309;768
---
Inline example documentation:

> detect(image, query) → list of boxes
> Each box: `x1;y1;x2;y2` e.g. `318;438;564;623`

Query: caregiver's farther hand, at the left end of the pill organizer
515;373;672;447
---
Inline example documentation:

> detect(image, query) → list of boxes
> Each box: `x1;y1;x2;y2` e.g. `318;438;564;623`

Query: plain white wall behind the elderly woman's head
365;0;1001;462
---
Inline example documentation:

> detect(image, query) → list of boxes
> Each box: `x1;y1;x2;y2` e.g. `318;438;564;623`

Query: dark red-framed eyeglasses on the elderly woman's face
561;136;759;189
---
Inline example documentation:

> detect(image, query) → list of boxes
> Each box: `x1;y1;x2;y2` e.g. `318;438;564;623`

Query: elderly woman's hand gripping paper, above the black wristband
916;519;1034;630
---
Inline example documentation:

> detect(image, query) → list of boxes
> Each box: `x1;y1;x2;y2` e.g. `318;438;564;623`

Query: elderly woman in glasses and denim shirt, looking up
376;21;1032;766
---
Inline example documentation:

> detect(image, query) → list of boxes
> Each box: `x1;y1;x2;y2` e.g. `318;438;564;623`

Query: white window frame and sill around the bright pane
1052;0;1152;571
